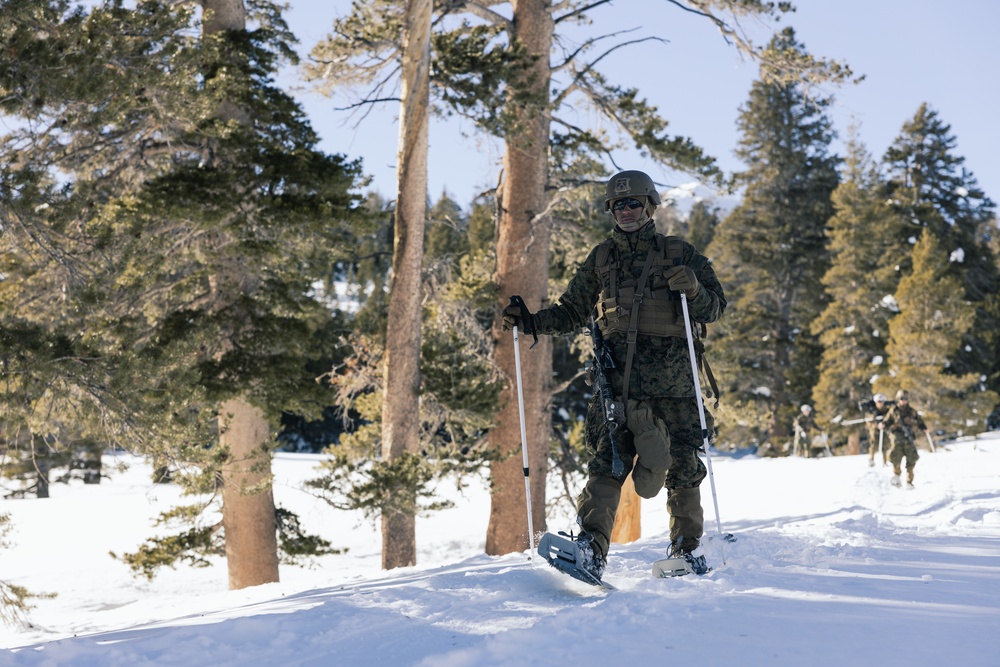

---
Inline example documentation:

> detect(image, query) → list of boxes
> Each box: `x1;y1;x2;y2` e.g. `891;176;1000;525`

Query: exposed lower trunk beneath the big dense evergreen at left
219;399;278;590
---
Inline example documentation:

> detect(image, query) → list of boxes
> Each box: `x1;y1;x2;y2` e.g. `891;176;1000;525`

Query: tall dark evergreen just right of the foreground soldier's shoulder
708;28;839;452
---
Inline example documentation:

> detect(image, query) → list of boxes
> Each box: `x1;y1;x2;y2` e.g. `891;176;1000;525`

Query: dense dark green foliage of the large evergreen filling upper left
0;0;364;576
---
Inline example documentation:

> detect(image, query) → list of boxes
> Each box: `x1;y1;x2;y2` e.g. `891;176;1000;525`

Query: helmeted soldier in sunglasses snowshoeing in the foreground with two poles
503;171;726;578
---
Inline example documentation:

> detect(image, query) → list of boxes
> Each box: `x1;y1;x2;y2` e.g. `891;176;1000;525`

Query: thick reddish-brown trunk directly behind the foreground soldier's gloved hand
486;0;554;555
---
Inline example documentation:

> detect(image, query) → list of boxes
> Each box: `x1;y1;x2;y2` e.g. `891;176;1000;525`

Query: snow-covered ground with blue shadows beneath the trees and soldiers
0;433;1000;667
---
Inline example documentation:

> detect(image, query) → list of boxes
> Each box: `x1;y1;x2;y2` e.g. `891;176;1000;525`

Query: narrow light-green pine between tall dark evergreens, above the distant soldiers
812;135;900;437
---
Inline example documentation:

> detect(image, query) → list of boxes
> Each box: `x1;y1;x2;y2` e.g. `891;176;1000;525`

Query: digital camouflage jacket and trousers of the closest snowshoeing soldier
533;222;726;554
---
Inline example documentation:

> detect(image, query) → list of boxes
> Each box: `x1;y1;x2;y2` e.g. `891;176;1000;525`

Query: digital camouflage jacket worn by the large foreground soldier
534;224;726;400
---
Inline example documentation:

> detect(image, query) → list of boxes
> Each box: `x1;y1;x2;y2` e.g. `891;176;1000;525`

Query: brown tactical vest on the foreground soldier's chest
595;235;686;338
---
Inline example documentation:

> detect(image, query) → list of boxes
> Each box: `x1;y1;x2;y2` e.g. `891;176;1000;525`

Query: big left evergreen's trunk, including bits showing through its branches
201;0;278;590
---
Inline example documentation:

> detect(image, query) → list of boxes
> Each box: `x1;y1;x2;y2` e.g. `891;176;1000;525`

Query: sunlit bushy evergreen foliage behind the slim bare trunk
310;195;503;518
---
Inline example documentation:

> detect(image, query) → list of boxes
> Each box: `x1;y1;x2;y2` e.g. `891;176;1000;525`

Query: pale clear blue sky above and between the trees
286;0;1000;206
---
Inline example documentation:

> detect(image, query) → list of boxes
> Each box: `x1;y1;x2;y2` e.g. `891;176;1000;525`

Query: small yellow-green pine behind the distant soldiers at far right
876;234;997;434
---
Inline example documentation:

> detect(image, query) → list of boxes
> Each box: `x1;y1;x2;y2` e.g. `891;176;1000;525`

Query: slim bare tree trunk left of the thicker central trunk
382;0;432;570
